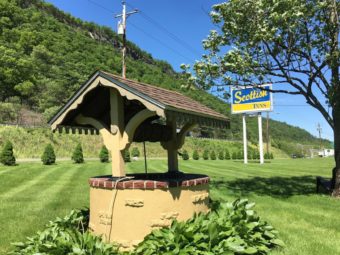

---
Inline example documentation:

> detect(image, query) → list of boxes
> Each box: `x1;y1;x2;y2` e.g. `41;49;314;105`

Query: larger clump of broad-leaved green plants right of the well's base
135;199;284;255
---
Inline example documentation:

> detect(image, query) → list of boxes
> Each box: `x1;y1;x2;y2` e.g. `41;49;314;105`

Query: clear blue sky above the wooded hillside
43;0;333;141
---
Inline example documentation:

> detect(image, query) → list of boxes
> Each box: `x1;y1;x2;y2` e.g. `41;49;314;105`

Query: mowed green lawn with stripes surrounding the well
0;159;340;255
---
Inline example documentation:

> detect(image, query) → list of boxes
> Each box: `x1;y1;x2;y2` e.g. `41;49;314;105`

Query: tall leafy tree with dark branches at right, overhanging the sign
191;0;340;196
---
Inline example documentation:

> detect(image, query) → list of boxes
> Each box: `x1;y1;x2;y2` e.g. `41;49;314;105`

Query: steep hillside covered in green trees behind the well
0;0;329;153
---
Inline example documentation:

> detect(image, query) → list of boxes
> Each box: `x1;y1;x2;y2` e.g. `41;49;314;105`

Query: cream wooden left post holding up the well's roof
108;89;125;177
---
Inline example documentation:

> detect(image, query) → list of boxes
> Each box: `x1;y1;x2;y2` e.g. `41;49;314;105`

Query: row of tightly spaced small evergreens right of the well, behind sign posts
181;150;274;160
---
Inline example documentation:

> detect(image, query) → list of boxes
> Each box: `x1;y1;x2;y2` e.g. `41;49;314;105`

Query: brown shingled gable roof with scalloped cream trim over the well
49;71;229;130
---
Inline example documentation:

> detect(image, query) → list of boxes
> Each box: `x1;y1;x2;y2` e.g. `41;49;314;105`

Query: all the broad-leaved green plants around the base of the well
11;199;284;255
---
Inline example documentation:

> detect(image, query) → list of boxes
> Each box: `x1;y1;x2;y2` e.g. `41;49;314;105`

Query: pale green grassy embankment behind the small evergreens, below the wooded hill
0;127;288;159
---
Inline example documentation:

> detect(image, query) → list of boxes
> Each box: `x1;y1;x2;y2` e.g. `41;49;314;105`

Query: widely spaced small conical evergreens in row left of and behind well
0;141;140;166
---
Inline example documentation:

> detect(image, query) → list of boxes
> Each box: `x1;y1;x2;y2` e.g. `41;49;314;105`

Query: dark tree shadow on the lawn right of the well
210;175;316;198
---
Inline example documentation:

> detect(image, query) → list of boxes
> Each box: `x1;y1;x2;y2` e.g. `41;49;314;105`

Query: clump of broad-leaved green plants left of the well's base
11;210;118;255
